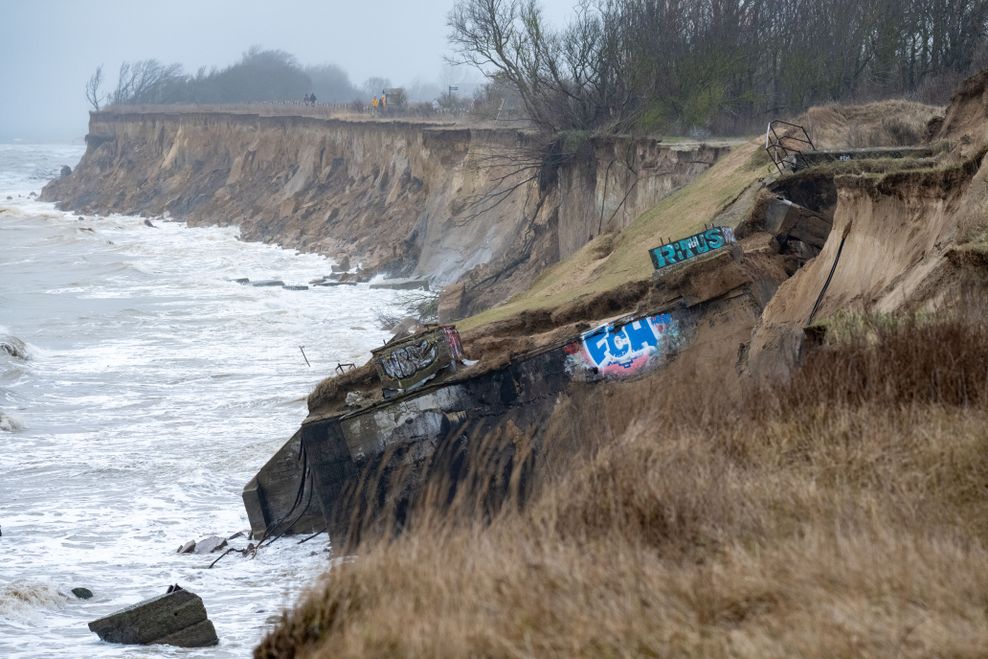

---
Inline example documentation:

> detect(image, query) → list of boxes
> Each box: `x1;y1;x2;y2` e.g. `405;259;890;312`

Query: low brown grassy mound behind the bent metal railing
798;99;943;149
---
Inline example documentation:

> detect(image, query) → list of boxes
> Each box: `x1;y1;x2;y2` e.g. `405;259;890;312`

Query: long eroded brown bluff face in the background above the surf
43;110;728;315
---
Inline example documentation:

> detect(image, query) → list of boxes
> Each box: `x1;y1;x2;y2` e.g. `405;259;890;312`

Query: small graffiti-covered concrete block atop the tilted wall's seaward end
373;325;463;392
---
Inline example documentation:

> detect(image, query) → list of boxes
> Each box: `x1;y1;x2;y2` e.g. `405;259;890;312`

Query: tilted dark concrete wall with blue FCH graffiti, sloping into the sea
243;235;785;545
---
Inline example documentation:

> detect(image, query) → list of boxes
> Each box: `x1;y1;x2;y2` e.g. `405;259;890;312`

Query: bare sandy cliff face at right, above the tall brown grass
748;150;988;382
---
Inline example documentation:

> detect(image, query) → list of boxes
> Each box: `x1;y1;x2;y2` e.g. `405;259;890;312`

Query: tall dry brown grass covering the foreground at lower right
256;319;988;657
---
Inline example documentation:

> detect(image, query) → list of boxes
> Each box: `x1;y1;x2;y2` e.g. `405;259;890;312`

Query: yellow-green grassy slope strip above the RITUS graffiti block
457;142;768;330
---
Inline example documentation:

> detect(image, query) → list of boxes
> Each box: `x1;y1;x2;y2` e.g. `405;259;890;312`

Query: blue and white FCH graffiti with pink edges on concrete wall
566;313;679;378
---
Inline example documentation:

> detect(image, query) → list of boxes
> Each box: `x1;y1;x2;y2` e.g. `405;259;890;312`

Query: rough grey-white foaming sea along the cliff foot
0;144;407;658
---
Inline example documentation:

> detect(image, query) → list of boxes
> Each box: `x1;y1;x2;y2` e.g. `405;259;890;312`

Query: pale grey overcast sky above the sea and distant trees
0;0;576;142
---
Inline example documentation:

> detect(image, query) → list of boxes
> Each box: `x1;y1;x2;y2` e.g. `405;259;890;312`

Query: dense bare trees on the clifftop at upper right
448;0;988;134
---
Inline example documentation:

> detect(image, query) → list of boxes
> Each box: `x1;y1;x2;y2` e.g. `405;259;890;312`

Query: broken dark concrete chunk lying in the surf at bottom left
89;586;219;648
